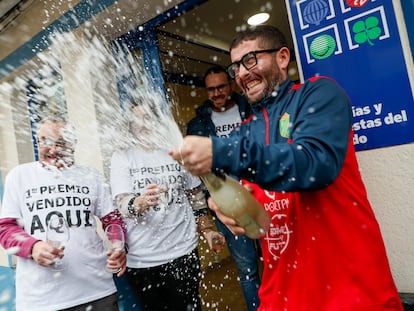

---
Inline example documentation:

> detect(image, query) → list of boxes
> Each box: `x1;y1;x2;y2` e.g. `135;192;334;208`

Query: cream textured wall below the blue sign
355;144;414;293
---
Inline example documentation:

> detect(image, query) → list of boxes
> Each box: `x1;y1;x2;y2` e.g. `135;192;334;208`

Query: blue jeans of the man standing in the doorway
215;217;260;311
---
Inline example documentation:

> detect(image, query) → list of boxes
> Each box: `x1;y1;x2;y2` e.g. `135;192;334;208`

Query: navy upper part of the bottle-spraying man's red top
212;77;352;191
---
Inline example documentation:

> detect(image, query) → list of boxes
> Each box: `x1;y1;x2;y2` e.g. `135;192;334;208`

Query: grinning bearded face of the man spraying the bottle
230;39;290;104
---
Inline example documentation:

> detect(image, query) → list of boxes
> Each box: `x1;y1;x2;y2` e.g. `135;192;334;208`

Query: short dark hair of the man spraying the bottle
230;25;288;51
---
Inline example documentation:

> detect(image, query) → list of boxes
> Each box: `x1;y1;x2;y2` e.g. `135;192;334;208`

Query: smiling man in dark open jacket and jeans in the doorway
187;66;260;311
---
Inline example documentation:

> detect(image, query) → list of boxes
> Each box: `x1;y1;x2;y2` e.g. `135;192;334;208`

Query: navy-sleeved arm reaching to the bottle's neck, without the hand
212;78;352;191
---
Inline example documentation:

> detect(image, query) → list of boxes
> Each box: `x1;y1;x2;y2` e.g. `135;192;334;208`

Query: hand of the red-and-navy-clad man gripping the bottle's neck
168;135;213;176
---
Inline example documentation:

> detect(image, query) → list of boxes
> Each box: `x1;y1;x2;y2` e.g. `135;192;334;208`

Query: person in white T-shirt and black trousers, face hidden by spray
110;104;225;311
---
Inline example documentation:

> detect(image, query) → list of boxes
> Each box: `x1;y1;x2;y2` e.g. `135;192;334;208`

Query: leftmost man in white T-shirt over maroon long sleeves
0;117;126;311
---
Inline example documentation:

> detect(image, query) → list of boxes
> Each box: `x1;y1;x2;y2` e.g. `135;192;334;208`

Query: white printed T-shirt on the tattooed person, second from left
111;148;200;268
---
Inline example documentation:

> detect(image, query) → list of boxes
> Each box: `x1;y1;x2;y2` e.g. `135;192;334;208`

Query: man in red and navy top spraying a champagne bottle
170;26;403;311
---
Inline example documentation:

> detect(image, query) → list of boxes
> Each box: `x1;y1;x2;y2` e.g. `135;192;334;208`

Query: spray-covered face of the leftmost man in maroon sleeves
37;121;75;169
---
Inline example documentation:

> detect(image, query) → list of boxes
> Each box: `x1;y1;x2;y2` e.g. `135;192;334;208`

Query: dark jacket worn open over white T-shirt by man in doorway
187;92;253;137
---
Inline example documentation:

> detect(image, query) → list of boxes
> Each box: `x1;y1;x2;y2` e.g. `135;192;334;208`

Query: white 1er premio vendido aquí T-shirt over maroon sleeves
1;162;116;311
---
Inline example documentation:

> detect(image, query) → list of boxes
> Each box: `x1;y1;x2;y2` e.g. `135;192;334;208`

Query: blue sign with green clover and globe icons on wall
289;0;414;150
